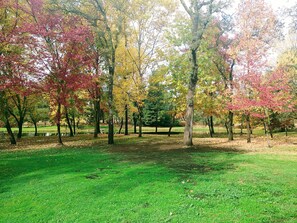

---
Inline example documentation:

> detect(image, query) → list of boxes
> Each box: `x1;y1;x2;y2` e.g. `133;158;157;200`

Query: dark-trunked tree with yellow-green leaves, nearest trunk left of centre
52;0;127;144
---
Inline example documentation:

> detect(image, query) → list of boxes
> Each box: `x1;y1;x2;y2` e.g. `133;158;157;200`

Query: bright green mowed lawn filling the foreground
0;135;297;223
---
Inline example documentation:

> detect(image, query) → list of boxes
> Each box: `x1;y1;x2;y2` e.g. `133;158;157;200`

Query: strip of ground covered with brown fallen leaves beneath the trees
0;134;297;155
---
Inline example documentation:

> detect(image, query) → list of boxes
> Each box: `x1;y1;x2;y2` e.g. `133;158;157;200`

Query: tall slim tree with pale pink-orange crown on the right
231;0;277;143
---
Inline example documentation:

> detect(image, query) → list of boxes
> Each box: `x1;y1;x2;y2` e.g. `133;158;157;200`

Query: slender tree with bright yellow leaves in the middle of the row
125;0;175;137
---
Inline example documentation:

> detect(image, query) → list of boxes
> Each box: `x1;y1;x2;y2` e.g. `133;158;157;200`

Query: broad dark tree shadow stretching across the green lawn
0;139;243;201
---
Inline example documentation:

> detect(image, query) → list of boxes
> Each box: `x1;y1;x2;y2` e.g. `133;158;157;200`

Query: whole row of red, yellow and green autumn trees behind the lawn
0;0;297;146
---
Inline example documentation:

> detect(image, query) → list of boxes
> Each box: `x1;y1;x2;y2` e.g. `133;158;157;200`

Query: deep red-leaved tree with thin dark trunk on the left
23;0;90;144
